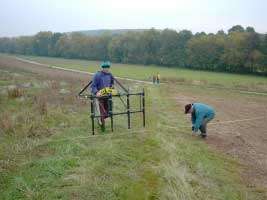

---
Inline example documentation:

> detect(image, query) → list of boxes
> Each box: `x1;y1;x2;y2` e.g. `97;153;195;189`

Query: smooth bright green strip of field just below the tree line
19;56;267;92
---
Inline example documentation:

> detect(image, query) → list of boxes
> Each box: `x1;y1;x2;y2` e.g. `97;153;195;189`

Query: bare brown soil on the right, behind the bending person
176;93;267;189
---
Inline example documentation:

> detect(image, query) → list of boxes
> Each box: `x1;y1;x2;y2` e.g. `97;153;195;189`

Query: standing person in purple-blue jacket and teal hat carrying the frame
91;61;114;131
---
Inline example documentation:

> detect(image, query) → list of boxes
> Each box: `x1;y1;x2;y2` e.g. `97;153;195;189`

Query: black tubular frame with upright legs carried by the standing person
78;78;146;135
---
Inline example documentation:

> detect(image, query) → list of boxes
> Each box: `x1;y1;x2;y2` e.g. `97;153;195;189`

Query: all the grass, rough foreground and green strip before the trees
0;54;267;200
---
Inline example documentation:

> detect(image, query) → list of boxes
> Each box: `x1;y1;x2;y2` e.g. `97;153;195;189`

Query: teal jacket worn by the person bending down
191;103;215;132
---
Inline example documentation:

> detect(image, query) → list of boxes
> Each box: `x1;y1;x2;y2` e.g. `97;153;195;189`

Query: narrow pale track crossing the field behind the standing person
15;57;153;85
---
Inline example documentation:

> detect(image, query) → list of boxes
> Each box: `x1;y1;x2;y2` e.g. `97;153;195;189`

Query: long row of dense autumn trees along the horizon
0;25;267;75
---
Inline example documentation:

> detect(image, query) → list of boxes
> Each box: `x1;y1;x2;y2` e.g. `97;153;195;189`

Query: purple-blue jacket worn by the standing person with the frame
91;71;114;94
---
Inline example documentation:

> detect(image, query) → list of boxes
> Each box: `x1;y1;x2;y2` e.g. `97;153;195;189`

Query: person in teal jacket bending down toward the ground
185;103;215;138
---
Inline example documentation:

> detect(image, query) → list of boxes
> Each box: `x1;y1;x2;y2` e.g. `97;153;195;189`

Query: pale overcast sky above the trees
0;0;267;37
